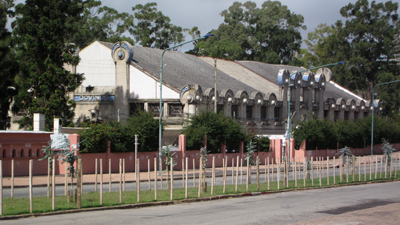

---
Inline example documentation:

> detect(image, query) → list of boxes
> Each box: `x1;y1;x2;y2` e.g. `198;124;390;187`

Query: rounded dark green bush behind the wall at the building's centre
182;111;246;153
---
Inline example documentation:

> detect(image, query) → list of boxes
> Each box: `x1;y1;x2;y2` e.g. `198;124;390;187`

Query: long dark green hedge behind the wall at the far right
293;117;400;150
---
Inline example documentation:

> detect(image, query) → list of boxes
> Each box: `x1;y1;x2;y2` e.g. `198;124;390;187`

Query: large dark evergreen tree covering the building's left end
14;0;83;130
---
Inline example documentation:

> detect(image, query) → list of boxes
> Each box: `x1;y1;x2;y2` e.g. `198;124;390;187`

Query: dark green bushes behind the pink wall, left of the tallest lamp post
80;111;159;153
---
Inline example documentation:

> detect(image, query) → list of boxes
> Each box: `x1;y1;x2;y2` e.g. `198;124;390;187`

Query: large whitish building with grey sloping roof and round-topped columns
65;41;379;141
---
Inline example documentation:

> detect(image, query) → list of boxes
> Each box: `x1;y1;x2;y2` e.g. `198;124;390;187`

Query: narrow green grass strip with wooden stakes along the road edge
3;171;400;216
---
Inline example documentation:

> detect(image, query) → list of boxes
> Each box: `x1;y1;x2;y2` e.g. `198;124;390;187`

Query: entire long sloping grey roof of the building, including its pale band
96;42;362;100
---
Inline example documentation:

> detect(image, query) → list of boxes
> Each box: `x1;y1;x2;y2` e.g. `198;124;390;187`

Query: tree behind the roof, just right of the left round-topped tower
129;2;184;49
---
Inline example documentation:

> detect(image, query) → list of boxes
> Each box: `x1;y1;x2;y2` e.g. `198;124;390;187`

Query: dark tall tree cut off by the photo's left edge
0;0;17;130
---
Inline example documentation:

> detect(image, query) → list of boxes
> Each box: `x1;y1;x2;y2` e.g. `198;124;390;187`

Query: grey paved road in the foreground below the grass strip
1;182;400;225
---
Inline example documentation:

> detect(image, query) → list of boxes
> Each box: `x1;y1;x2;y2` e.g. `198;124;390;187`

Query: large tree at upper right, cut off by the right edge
306;0;400;105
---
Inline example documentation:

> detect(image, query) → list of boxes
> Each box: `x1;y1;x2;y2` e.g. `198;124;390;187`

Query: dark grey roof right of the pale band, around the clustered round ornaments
237;61;357;100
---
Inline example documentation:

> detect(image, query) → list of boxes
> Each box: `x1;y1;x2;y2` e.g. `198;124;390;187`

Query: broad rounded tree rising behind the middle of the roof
193;1;305;64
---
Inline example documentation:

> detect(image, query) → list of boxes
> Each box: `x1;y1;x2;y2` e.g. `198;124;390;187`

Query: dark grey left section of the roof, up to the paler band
128;47;256;95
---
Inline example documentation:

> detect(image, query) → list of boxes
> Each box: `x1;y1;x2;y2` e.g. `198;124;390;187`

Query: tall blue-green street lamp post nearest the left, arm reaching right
158;34;214;176
